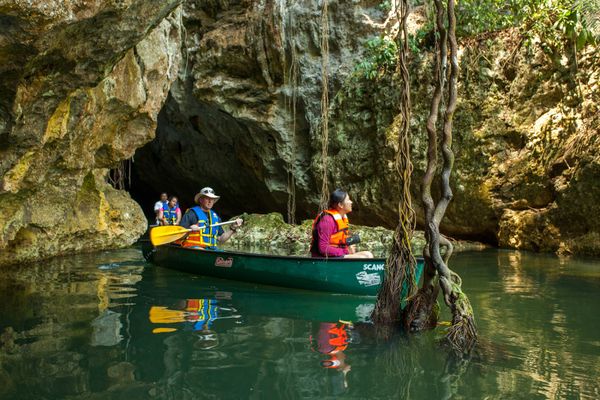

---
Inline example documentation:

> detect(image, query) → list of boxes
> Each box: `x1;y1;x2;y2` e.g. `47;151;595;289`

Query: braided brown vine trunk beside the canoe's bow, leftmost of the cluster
372;0;417;335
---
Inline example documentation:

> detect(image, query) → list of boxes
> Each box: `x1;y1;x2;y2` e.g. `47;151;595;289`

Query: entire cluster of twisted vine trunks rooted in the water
372;0;477;353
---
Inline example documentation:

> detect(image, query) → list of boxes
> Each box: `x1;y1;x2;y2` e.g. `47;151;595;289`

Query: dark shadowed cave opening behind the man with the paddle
115;103;287;223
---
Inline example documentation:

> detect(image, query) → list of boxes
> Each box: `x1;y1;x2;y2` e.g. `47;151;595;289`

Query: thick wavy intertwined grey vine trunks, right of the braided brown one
403;0;477;353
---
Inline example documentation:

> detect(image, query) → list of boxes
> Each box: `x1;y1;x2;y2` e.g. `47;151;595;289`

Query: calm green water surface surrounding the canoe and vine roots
0;249;600;400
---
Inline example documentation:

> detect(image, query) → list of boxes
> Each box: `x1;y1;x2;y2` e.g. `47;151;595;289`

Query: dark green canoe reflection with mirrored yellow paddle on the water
138;268;376;324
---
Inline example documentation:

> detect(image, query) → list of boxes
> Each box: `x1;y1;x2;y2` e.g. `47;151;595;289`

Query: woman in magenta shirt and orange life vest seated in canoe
310;189;373;258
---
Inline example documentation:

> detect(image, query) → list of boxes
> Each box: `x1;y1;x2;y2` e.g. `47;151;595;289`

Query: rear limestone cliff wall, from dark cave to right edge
136;0;600;253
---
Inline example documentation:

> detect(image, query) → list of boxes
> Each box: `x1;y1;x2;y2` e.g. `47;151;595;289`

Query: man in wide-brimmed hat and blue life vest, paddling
180;187;244;250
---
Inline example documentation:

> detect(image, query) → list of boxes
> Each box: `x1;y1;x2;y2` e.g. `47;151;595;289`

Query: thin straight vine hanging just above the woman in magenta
319;0;329;211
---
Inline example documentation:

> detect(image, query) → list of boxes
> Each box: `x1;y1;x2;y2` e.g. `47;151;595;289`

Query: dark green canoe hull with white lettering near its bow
144;241;423;295
